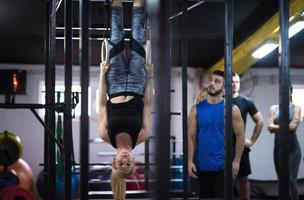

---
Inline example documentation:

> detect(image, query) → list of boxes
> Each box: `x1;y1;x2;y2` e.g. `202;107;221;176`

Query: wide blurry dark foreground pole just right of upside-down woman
147;0;171;200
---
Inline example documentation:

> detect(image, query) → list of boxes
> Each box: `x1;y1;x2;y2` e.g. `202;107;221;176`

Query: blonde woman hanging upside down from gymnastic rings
98;0;152;200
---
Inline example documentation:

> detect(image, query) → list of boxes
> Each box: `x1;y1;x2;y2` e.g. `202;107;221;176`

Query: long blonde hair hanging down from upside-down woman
111;158;136;200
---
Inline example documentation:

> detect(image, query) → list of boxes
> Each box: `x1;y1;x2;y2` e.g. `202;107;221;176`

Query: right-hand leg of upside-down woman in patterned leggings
127;0;147;95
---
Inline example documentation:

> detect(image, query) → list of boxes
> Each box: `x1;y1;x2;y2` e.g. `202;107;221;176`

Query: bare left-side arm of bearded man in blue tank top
188;106;197;178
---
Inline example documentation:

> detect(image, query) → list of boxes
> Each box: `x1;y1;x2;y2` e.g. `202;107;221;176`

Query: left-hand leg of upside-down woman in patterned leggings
107;0;126;95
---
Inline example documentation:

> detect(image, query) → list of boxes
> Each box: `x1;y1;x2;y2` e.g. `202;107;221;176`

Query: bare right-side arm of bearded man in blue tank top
232;106;245;177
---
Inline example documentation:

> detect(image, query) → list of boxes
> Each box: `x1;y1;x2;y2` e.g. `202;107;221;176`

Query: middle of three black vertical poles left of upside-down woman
63;0;73;200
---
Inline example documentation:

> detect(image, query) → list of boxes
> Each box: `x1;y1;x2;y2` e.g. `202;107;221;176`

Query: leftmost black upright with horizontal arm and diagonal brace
0;0;64;200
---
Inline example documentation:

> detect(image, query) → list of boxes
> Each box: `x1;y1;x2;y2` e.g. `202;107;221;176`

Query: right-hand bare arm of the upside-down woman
137;64;153;144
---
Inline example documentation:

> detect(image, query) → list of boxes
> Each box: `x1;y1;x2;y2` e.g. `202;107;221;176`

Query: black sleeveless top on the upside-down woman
108;95;144;148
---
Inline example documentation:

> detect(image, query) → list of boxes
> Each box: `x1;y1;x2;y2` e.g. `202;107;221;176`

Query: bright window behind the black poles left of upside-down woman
40;83;91;117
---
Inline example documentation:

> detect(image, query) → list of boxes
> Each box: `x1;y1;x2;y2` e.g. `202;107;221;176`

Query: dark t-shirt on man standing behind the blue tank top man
233;95;258;126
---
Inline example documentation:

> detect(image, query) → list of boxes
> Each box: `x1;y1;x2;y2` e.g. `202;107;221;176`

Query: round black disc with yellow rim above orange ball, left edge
0;131;22;166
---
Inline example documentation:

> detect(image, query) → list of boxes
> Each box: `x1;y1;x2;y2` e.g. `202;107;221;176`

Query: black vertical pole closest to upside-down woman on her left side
79;0;90;200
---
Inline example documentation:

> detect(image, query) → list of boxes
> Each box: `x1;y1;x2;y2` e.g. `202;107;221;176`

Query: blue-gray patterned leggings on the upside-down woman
107;6;147;97
